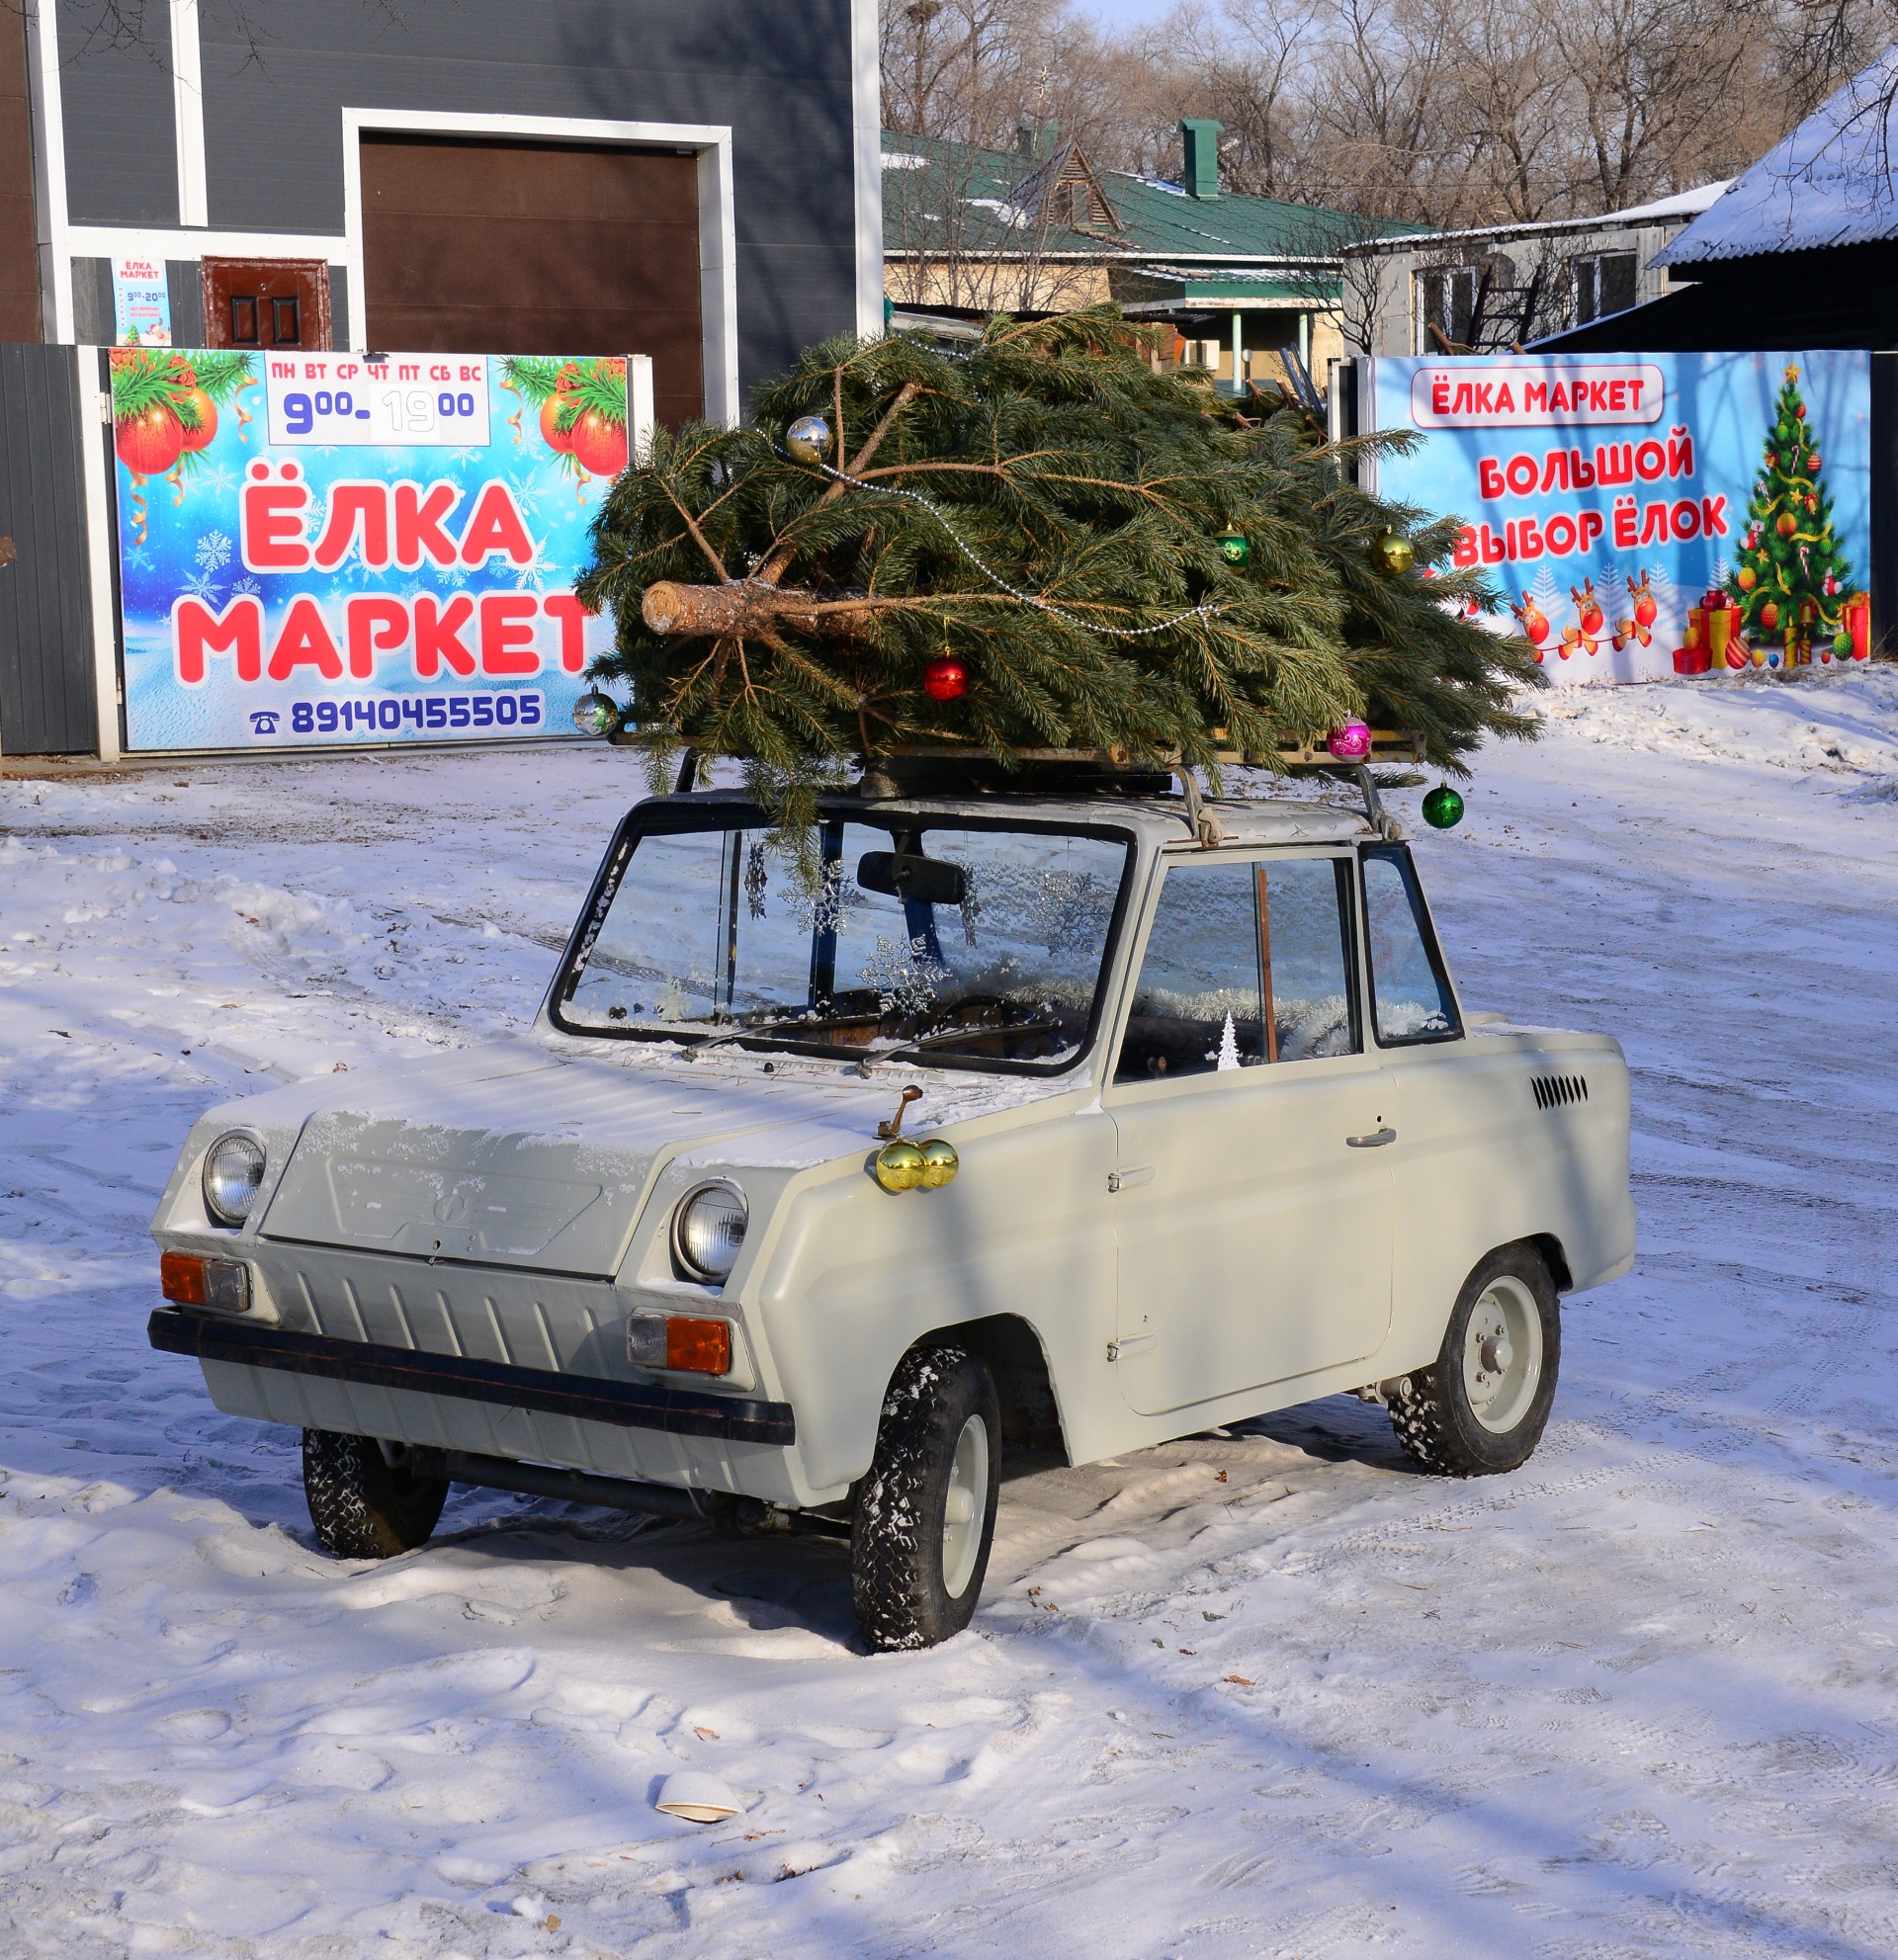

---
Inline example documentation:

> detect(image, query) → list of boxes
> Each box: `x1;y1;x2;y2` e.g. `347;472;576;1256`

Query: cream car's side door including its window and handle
1102;851;1398;1415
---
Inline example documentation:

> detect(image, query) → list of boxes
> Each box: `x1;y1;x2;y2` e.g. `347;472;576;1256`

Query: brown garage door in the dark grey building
363;131;704;427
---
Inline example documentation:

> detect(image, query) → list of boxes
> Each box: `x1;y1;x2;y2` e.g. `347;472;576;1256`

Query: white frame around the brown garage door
343;108;741;425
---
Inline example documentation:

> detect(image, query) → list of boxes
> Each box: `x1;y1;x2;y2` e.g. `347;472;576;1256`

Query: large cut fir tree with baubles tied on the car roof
580;307;1539;811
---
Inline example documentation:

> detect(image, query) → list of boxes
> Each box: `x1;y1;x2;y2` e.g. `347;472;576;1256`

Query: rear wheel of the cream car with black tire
1390;1244;1563;1476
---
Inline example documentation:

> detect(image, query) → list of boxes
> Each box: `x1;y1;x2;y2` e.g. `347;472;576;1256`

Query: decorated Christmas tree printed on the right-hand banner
1725;367;1851;664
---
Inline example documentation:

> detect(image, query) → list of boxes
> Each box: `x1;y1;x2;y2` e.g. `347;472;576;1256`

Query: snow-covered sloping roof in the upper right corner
1653;45;1898;267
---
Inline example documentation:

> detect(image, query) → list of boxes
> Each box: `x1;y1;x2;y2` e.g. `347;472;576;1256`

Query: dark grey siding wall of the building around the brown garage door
59;0;857;390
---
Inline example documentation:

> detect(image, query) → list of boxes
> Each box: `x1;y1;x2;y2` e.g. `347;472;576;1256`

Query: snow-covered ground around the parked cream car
0;670;1898;1960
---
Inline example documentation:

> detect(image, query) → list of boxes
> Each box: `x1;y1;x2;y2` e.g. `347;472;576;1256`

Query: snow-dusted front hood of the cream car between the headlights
245;1051;1043;1278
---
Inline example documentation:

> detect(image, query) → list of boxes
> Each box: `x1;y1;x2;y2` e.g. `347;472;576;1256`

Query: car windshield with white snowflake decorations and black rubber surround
553;811;1131;1070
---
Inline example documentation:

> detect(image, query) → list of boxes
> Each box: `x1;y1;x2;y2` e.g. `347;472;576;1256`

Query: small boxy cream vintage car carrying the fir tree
151;778;1633;1649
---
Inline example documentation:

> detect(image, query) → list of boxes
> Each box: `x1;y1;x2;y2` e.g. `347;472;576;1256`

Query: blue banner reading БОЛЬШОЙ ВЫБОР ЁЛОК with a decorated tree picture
1368;349;1872;686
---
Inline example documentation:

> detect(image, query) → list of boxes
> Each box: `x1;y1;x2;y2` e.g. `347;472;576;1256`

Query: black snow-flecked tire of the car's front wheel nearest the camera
851;1346;1002;1653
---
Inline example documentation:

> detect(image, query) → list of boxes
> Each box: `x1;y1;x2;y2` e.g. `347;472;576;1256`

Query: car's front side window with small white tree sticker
1114;859;1359;1082
